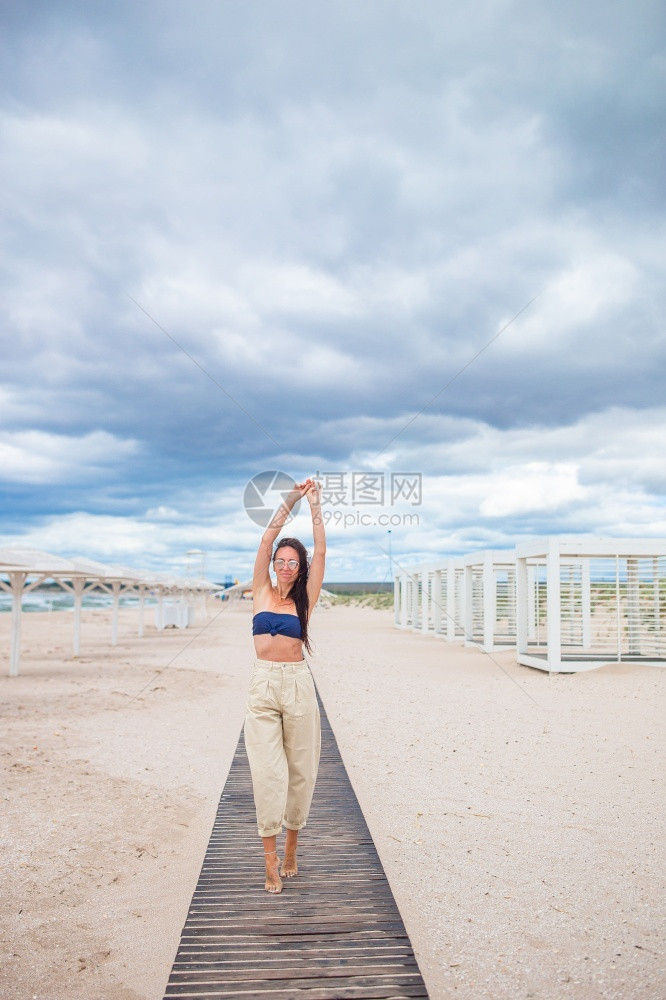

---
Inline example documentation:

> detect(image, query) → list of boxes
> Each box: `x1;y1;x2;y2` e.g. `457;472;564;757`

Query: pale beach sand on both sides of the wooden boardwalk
0;602;666;1000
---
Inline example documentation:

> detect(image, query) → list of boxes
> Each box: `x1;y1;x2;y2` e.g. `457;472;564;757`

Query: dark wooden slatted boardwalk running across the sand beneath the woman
165;702;428;1000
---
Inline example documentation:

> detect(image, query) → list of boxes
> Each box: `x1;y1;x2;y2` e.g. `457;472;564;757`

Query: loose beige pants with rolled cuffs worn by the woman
245;660;321;837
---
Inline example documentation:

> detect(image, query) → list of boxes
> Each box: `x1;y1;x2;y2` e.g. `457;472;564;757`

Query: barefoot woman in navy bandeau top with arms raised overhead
245;479;326;892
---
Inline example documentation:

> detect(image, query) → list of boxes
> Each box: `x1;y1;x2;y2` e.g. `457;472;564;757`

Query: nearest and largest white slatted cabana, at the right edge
516;536;666;673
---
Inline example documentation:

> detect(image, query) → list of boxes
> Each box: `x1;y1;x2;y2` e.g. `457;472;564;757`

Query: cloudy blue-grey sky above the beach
0;0;666;580
